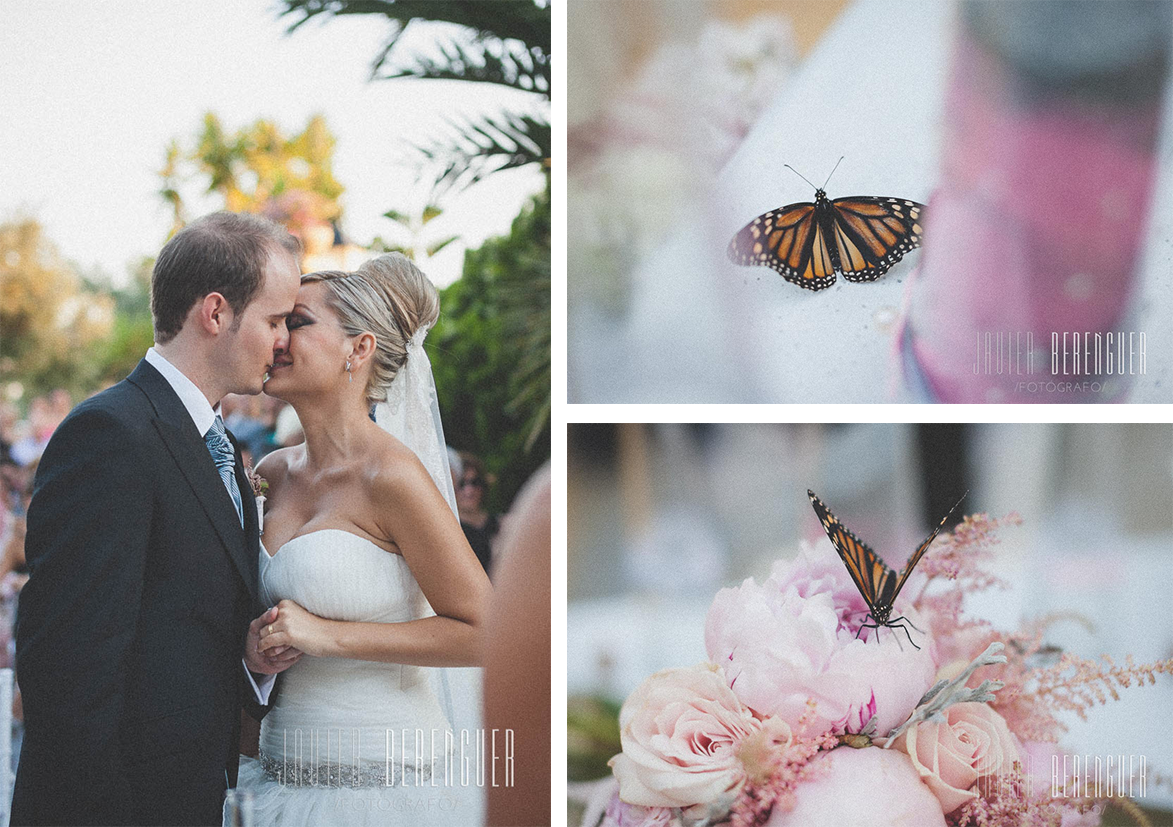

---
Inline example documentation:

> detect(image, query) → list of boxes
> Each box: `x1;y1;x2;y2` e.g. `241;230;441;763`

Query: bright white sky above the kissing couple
0;0;542;285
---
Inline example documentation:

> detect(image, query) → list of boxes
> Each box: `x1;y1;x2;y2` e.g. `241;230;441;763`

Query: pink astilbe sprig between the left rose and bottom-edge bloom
728;700;839;827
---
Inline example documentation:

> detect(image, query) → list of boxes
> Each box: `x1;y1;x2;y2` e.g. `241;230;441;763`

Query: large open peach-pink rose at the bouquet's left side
611;664;761;807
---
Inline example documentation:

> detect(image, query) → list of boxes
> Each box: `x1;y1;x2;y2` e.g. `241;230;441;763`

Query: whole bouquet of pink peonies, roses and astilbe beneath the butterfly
584;514;1173;827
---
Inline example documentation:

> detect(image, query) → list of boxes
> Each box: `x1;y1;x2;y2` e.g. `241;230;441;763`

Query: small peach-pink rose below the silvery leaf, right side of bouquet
894;703;1022;813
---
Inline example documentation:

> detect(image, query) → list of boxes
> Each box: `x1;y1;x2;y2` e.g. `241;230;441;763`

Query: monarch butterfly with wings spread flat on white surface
727;158;924;290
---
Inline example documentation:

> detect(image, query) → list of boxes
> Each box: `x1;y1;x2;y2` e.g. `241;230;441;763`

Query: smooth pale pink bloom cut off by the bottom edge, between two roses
766;746;945;827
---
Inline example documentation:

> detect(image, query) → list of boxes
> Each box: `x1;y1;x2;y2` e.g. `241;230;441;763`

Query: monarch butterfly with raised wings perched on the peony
807;488;968;649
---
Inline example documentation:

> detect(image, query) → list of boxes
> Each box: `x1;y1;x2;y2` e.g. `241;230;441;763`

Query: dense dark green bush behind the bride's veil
428;179;550;509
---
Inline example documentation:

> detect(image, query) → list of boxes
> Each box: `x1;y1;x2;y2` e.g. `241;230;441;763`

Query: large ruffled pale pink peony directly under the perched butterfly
705;541;936;734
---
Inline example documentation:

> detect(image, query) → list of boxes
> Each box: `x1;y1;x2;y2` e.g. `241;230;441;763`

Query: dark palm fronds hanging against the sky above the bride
282;0;551;192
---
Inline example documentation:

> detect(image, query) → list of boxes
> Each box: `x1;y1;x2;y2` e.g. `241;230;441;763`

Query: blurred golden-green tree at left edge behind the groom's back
0;218;114;393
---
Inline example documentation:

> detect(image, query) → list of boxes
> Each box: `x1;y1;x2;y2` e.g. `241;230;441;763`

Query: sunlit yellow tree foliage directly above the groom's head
160;113;343;233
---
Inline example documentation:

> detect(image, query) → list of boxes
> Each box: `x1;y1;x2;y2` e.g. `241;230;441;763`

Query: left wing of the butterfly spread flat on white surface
727;202;835;290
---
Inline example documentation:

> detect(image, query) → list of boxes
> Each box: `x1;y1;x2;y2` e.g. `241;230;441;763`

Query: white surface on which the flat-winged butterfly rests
714;0;952;402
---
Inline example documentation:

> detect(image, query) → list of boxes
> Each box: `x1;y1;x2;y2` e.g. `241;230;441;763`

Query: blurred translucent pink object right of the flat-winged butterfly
908;29;1160;402
